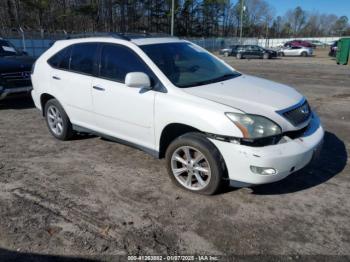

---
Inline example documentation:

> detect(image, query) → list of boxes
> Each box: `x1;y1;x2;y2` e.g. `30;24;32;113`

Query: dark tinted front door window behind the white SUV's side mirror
100;45;153;83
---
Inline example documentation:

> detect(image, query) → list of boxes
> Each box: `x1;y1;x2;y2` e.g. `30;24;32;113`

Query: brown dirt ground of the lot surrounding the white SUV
0;48;350;256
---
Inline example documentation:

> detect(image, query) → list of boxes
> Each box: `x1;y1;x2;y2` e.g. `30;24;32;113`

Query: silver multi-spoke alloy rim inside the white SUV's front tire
171;146;211;190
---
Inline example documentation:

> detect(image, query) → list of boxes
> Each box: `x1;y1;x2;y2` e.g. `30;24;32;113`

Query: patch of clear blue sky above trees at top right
265;0;350;17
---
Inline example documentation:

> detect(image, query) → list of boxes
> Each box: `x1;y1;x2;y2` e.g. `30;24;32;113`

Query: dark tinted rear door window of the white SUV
70;43;98;75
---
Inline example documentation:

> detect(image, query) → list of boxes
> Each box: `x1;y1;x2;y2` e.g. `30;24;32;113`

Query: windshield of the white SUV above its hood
140;43;240;88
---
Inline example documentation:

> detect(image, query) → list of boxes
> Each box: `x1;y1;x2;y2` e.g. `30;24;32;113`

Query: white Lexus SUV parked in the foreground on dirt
32;36;324;194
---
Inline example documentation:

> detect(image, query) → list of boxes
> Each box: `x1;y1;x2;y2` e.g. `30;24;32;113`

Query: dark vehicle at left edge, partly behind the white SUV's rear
0;38;34;100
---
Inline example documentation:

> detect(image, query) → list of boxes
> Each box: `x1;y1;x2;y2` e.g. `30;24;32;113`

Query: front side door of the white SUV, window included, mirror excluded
92;44;156;149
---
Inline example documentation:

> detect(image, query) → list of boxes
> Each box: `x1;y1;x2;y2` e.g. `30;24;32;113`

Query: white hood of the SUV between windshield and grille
183;75;303;117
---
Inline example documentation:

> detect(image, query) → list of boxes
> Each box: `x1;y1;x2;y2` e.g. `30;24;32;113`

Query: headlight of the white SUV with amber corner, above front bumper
225;113;282;139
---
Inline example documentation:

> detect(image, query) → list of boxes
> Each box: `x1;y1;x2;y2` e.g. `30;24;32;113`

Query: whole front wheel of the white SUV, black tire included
165;133;227;195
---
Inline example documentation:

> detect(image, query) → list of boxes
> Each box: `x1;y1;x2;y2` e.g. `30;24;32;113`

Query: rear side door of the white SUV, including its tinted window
50;43;98;127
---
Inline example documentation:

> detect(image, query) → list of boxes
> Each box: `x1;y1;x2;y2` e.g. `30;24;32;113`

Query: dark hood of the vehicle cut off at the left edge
0;56;35;73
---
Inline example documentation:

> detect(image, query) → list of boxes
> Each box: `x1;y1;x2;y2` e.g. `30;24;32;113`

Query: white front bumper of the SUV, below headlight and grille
211;114;324;185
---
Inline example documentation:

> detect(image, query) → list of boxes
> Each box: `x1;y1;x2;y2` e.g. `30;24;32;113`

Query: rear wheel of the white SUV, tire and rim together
45;99;74;141
